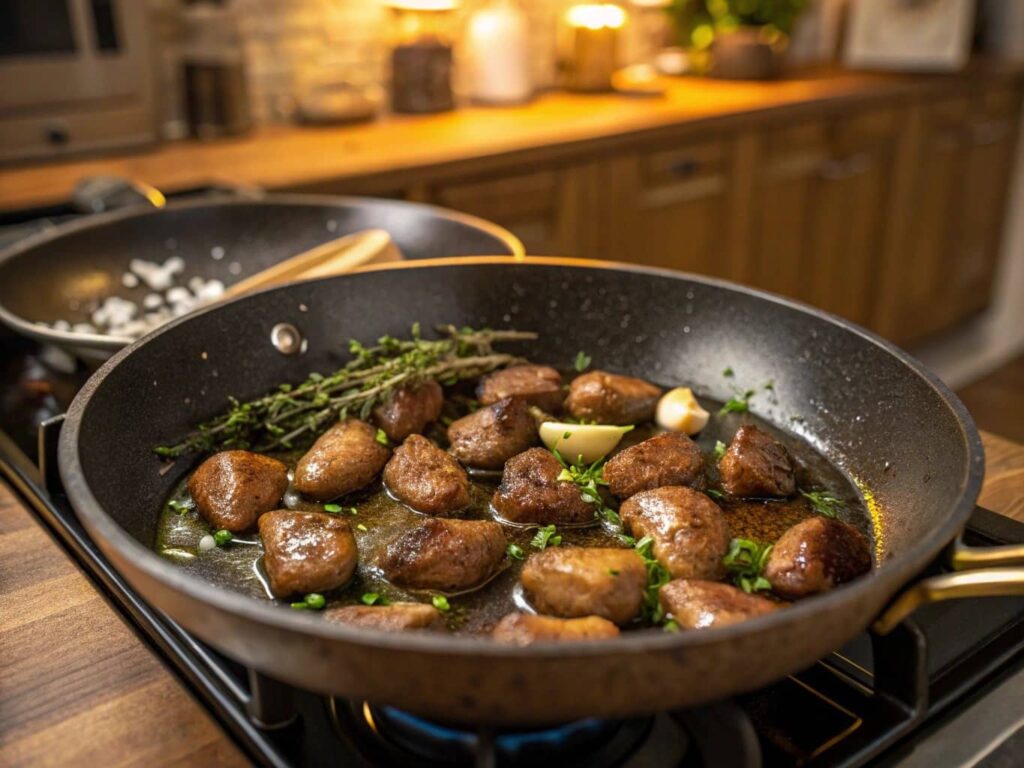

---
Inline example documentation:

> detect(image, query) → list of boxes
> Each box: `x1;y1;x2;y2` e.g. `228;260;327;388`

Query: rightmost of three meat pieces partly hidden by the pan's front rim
658;579;778;630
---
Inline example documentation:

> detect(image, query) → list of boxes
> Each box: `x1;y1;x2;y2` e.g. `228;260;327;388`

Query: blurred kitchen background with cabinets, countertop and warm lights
0;0;1024;439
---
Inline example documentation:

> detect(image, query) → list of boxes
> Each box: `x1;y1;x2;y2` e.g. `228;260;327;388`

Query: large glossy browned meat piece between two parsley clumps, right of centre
618;485;731;580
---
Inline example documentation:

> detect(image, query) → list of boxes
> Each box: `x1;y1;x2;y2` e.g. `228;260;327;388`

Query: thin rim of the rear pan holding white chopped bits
0;193;526;352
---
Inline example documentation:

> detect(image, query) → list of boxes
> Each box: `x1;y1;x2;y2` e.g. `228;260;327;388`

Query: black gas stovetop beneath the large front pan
0;199;1024;768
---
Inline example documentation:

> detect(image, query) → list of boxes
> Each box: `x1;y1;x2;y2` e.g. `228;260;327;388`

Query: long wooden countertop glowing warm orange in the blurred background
0;62;1022;209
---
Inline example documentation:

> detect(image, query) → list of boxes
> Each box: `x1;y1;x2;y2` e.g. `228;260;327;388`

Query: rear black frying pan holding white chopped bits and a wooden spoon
0;195;523;359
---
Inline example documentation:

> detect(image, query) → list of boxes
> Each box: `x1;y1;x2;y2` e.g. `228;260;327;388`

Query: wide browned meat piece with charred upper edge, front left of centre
380;517;506;592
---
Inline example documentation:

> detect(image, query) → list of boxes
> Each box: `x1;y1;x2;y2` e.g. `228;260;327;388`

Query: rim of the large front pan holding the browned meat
58;256;984;659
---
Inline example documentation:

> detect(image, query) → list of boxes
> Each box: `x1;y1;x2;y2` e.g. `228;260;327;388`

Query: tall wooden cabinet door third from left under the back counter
748;110;899;324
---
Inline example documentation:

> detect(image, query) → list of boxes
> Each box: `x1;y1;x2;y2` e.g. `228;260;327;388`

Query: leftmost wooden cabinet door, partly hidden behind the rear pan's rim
430;165;597;257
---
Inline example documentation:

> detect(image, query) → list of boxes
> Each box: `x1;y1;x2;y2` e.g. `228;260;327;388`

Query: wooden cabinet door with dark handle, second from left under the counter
601;138;738;279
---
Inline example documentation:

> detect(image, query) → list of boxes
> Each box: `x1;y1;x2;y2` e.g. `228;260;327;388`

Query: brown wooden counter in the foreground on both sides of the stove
0;433;1024;766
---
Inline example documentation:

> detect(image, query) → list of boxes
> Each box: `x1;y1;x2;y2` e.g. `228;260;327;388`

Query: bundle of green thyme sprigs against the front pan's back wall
154;326;537;459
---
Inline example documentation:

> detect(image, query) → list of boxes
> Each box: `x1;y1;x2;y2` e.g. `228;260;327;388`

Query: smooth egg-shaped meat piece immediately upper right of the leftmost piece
293;419;391;502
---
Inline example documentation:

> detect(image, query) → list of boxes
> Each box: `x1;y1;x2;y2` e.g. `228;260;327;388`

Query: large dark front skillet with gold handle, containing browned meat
59;257;1024;724
